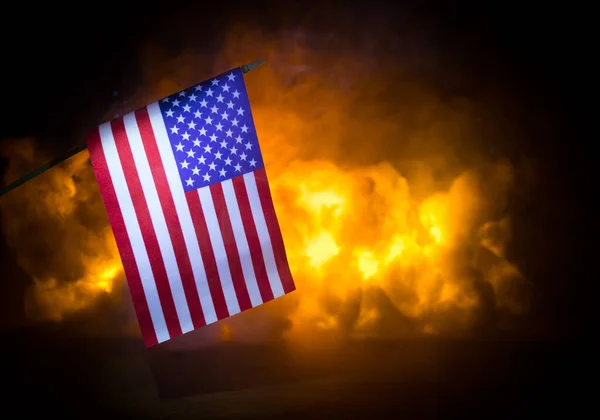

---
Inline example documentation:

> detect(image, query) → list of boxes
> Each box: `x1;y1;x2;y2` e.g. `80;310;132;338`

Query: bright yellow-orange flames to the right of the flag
271;161;518;340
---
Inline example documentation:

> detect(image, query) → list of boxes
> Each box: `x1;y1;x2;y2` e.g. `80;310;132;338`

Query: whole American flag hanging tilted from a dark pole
88;68;295;347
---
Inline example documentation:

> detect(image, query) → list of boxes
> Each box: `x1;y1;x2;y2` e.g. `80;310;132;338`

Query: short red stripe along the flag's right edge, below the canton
254;168;296;293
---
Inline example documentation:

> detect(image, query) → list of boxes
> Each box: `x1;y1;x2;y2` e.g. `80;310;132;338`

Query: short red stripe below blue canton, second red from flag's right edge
231;176;273;302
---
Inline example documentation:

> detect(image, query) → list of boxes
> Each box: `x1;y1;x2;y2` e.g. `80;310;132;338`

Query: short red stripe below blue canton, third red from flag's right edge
209;183;252;311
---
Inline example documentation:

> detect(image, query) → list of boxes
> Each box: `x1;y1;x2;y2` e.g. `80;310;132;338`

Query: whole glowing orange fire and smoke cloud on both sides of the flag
2;27;527;340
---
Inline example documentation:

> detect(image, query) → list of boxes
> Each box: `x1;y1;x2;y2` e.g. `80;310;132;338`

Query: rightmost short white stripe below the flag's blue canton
244;172;284;298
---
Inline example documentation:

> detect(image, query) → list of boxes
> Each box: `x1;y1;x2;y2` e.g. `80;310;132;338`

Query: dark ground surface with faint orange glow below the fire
3;329;594;419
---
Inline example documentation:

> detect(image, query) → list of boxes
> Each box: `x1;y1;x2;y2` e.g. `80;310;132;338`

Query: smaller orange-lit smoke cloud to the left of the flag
2;139;122;321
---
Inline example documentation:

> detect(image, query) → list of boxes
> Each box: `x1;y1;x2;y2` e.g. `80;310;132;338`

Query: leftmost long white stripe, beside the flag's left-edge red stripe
99;123;170;343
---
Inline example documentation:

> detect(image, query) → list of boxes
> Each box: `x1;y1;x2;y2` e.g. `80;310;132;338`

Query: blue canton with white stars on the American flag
159;68;263;192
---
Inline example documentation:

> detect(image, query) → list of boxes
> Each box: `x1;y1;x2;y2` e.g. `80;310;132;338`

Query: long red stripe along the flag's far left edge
87;128;158;347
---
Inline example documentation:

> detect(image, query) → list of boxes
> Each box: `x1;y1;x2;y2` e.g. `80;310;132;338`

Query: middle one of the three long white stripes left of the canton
123;112;194;333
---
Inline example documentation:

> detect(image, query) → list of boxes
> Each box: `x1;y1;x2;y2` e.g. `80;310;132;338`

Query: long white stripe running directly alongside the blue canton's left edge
146;102;217;324
